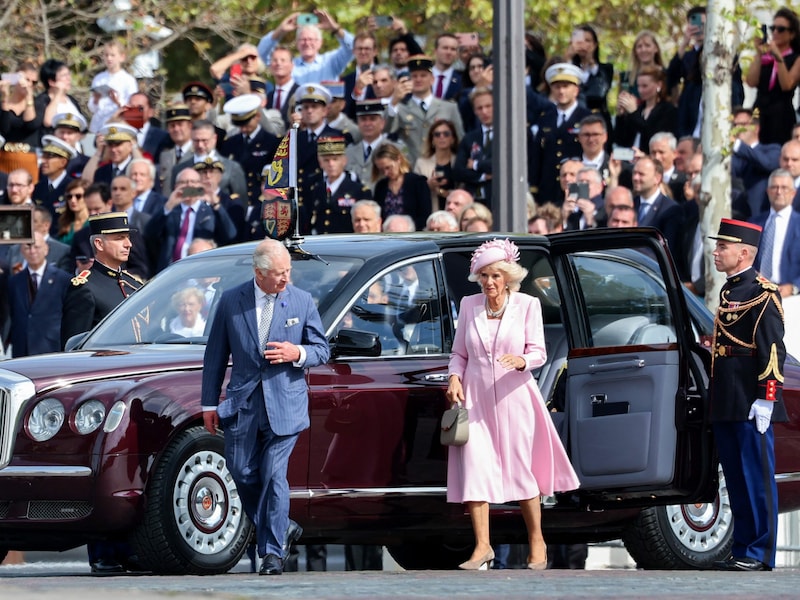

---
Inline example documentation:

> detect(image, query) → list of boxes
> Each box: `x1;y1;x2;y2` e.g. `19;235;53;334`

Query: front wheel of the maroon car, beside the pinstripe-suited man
131;427;253;575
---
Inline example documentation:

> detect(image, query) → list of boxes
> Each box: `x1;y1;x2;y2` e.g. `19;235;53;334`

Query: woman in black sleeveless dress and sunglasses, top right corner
746;7;800;144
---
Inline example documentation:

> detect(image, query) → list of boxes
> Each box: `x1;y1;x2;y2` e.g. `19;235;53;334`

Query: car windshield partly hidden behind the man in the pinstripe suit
81;253;363;349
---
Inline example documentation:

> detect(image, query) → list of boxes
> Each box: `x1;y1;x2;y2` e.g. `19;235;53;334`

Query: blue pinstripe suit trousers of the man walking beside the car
220;386;297;557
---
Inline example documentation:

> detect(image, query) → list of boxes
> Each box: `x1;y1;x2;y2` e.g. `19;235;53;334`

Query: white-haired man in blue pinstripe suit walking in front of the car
201;240;330;575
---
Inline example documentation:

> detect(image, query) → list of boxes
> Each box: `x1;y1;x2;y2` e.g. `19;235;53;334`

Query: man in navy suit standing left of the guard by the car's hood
8;232;70;358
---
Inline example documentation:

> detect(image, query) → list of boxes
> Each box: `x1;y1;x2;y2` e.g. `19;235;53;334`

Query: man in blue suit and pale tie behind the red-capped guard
751;169;800;298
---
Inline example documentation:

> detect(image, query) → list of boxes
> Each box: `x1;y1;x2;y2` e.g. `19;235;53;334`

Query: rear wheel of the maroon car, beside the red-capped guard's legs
622;469;733;569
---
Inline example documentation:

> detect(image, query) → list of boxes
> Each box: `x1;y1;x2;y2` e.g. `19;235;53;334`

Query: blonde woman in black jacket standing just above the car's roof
372;142;432;231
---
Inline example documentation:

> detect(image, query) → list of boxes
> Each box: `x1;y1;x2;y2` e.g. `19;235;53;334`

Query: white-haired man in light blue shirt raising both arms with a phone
258;9;354;84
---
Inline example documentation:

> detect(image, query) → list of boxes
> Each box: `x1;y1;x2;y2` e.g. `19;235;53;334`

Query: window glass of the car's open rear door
573;255;676;347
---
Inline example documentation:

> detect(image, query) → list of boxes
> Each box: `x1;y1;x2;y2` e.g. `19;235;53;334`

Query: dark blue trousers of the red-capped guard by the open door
714;421;778;567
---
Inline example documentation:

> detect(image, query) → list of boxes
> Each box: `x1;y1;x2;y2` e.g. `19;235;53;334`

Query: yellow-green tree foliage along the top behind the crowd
0;0;780;102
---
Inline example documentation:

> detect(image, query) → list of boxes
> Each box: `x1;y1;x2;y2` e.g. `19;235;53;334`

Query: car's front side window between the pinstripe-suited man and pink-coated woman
339;261;449;356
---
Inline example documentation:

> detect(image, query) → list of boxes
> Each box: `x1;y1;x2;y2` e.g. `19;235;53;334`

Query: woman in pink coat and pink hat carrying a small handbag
447;240;579;570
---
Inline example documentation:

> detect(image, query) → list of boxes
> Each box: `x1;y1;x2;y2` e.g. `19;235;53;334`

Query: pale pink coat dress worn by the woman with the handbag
447;292;580;503
